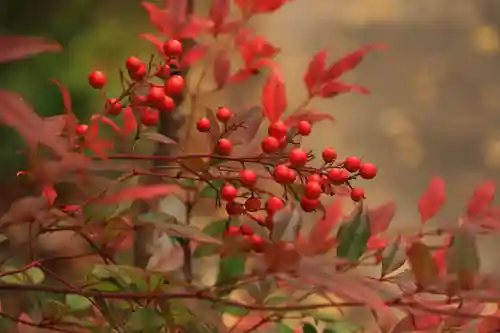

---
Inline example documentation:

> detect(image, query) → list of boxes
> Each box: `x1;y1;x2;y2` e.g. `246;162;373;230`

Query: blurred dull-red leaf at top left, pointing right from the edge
0;36;62;63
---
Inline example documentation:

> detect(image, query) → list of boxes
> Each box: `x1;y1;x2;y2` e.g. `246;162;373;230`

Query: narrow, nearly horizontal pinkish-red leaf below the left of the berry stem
101;184;178;203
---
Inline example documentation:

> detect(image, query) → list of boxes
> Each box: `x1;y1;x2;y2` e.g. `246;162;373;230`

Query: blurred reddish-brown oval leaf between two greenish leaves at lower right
406;242;439;288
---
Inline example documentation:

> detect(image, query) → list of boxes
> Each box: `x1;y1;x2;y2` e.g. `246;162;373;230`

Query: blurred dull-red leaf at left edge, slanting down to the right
0;90;68;156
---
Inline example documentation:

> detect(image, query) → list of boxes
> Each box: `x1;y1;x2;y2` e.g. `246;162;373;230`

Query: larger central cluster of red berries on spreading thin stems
193;111;377;220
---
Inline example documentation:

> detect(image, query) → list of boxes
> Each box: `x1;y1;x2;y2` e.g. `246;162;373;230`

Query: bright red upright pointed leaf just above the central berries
262;68;287;122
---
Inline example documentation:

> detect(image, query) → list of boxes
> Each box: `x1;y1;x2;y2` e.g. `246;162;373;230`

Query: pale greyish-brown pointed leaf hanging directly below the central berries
270;205;302;242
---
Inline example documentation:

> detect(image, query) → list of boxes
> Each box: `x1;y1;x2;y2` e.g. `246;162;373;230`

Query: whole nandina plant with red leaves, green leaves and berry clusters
0;0;500;333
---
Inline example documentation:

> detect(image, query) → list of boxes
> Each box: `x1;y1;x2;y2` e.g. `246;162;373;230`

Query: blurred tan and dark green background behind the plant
0;0;500;264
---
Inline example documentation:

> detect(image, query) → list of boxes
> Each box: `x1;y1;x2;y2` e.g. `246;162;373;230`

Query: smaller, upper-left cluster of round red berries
83;39;185;131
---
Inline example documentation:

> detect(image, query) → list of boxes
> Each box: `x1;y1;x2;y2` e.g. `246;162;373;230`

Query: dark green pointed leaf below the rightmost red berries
337;209;371;261
